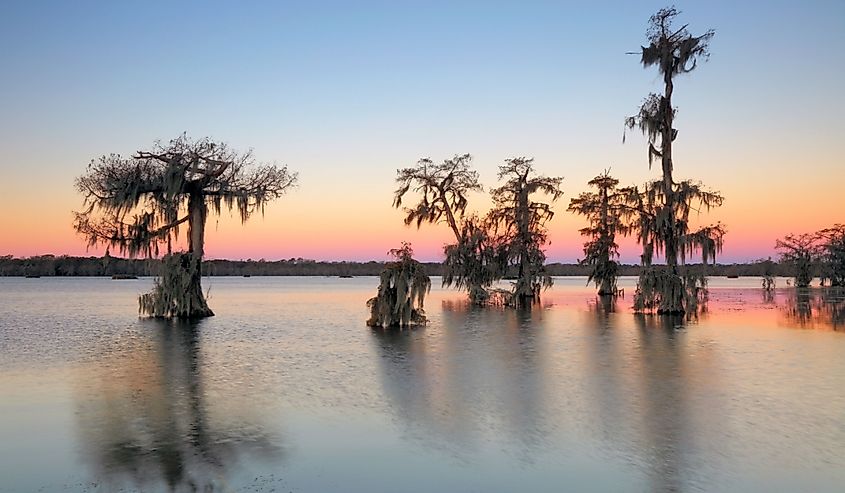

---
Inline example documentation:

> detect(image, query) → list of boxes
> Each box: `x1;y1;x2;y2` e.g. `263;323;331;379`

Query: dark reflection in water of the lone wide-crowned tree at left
77;319;282;491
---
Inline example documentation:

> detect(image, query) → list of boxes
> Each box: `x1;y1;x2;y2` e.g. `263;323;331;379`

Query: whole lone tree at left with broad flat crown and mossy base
74;134;296;318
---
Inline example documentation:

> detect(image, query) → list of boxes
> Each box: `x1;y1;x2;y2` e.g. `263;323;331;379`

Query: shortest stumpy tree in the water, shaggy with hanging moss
367;242;431;327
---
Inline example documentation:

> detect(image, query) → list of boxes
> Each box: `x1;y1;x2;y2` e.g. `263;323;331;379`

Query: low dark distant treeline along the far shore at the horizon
0;255;793;276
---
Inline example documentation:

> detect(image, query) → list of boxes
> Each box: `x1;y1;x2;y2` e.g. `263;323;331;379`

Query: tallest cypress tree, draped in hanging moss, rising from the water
625;8;724;313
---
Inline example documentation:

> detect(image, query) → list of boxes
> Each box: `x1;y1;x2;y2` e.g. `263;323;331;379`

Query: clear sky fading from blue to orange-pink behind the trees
0;0;845;262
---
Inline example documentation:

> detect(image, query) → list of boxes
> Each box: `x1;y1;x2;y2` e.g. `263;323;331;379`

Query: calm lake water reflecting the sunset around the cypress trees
0;277;845;492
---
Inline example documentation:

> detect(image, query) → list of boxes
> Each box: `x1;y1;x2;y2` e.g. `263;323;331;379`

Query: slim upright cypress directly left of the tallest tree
569;170;628;295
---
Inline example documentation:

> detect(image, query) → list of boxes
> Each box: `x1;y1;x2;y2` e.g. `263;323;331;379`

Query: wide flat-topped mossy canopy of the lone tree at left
74;134;297;257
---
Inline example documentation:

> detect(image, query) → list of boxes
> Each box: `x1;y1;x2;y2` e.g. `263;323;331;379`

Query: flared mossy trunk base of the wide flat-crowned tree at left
138;252;214;318
